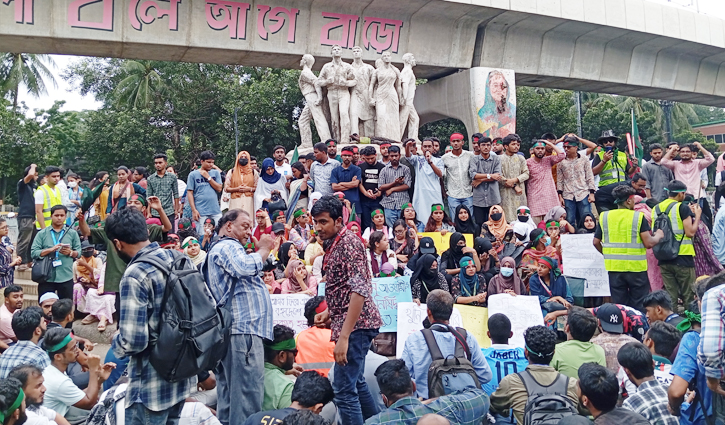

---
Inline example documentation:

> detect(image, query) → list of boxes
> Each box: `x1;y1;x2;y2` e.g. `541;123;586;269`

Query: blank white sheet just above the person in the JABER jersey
486;294;544;347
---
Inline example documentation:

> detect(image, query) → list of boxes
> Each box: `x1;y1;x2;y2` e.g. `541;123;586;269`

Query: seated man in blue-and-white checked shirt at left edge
0;307;50;379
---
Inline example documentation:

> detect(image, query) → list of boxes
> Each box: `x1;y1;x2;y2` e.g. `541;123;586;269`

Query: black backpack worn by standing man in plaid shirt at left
133;251;232;382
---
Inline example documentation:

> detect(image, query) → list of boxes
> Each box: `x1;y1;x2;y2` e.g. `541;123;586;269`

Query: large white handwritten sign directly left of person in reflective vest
561;233;610;297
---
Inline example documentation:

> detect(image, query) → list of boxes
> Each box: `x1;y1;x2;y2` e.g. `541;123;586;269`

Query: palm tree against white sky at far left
0;53;57;110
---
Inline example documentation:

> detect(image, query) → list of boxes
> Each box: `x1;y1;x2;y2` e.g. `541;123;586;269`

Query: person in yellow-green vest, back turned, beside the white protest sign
594;185;664;311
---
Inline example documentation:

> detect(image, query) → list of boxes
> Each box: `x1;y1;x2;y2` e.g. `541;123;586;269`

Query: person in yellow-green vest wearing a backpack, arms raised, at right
652;180;702;306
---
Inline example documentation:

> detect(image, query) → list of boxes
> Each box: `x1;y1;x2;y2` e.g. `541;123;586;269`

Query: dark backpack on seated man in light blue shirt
421;324;481;398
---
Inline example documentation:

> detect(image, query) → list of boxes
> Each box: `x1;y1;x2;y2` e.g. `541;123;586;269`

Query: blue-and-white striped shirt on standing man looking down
204;237;274;339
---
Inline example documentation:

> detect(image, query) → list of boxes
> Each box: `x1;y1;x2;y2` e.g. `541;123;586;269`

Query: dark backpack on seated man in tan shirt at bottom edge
517;370;578;425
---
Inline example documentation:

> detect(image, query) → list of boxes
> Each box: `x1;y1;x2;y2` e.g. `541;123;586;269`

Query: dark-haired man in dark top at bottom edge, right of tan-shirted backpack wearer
579;363;649;425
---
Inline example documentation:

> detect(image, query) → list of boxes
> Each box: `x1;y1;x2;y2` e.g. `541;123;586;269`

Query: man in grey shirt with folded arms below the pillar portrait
468;137;501;225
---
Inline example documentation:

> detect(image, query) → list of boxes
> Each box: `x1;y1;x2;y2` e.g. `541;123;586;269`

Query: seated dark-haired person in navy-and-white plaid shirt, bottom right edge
617;342;680;425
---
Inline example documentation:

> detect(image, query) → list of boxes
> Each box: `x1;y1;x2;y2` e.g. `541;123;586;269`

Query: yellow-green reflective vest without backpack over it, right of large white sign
599;209;647;272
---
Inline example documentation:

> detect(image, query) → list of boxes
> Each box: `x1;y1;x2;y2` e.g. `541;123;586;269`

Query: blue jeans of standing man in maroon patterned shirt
332;328;387;425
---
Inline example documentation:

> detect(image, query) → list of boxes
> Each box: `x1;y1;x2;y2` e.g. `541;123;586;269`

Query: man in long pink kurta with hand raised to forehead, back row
526;139;564;224
